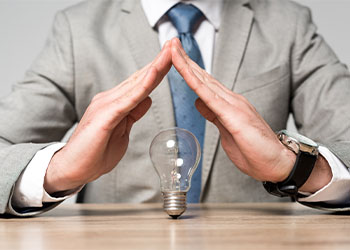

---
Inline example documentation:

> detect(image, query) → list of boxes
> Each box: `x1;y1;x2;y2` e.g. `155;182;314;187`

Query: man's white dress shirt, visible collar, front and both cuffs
11;0;350;207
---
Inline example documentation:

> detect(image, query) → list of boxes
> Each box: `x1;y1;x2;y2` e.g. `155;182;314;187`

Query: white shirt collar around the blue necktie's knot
141;0;223;30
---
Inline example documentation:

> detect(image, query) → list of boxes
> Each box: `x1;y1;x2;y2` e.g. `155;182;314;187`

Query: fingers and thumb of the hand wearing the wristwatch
171;39;256;139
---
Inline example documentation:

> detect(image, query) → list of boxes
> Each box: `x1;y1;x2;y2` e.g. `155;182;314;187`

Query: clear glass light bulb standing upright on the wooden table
149;128;201;219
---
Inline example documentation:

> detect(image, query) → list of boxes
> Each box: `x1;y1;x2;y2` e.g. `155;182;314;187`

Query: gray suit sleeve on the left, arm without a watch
0;12;77;215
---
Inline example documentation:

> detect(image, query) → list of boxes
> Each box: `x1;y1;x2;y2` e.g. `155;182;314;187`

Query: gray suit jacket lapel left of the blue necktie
121;1;175;130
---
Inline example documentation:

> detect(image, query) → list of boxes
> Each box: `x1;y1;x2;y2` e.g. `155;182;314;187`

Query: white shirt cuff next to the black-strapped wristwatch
299;146;350;204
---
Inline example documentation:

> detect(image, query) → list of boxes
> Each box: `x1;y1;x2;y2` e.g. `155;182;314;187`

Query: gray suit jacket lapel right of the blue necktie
202;0;253;195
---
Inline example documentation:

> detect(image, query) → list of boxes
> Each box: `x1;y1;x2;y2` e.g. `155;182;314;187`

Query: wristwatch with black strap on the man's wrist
263;130;318;200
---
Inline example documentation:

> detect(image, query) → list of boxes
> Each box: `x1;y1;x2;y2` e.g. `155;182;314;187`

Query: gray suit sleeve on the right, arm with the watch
291;5;350;210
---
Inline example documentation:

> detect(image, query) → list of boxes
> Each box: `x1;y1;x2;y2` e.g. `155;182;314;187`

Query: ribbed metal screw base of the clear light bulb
163;191;187;219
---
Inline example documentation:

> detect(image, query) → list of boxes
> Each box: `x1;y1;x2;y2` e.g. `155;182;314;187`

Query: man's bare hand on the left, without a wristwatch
44;42;172;194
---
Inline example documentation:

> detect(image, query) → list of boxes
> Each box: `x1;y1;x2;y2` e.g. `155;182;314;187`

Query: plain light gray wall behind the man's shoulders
0;0;350;98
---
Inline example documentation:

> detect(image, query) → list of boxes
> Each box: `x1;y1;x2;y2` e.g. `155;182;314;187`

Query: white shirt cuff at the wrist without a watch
11;143;67;208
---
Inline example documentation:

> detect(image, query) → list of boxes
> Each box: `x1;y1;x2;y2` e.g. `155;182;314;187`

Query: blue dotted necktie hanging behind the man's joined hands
167;3;205;203
